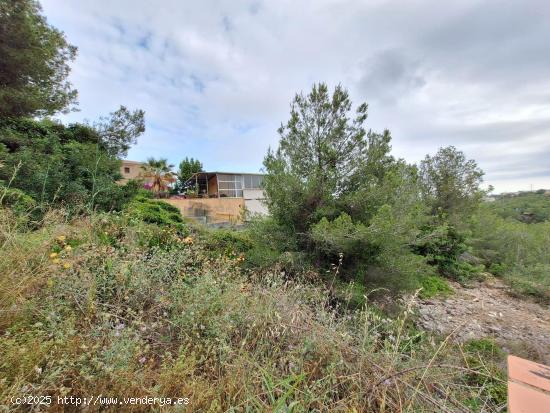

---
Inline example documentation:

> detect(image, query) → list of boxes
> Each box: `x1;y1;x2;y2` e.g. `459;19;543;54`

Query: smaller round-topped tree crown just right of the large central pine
420;146;485;215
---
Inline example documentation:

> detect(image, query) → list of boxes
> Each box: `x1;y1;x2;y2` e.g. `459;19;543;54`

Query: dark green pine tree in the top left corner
0;0;77;117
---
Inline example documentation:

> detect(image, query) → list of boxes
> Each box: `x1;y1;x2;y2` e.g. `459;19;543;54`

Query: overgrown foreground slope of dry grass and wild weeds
0;210;506;412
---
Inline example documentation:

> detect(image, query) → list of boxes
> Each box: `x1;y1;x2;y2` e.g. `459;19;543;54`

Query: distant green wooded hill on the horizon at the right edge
490;189;550;223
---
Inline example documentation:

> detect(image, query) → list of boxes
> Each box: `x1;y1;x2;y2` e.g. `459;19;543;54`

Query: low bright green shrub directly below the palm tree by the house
127;196;185;230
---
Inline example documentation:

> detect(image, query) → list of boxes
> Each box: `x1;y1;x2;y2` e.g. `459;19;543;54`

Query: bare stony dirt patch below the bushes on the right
417;279;550;364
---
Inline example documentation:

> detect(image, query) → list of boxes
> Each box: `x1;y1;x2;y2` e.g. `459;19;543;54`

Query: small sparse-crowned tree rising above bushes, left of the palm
94;106;145;157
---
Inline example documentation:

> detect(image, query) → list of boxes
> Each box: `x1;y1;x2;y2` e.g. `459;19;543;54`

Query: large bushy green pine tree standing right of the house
264;84;431;290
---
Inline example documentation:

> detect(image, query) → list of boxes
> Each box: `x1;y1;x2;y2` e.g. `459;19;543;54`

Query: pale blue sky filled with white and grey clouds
41;0;550;193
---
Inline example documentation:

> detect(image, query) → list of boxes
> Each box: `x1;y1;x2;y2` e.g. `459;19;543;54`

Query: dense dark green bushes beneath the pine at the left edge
0;118;144;210
